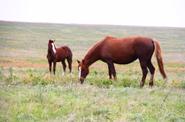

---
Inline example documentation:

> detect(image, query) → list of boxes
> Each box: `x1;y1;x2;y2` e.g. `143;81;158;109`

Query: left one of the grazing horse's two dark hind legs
139;59;148;87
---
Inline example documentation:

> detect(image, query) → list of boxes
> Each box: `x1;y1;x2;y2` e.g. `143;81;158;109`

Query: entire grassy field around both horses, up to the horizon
0;21;185;122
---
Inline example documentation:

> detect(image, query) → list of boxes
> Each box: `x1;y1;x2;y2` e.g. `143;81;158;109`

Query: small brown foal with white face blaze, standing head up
47;40;72;74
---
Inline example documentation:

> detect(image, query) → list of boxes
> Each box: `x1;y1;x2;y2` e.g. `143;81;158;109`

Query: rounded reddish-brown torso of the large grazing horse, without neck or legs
101;36;154;64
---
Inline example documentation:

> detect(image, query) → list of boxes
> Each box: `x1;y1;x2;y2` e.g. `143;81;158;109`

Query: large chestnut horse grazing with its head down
78;36;167;87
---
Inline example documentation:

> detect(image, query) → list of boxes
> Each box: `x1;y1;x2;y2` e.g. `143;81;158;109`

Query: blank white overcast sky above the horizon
0;0;185;27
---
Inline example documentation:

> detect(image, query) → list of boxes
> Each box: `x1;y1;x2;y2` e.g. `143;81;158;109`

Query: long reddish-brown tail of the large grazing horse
154;40;167;79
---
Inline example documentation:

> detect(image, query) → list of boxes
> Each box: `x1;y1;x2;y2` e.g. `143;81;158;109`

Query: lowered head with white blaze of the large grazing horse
77;60;89;84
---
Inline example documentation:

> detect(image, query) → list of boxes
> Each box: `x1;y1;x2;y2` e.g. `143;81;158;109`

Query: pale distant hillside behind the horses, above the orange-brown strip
0;21;185;61
